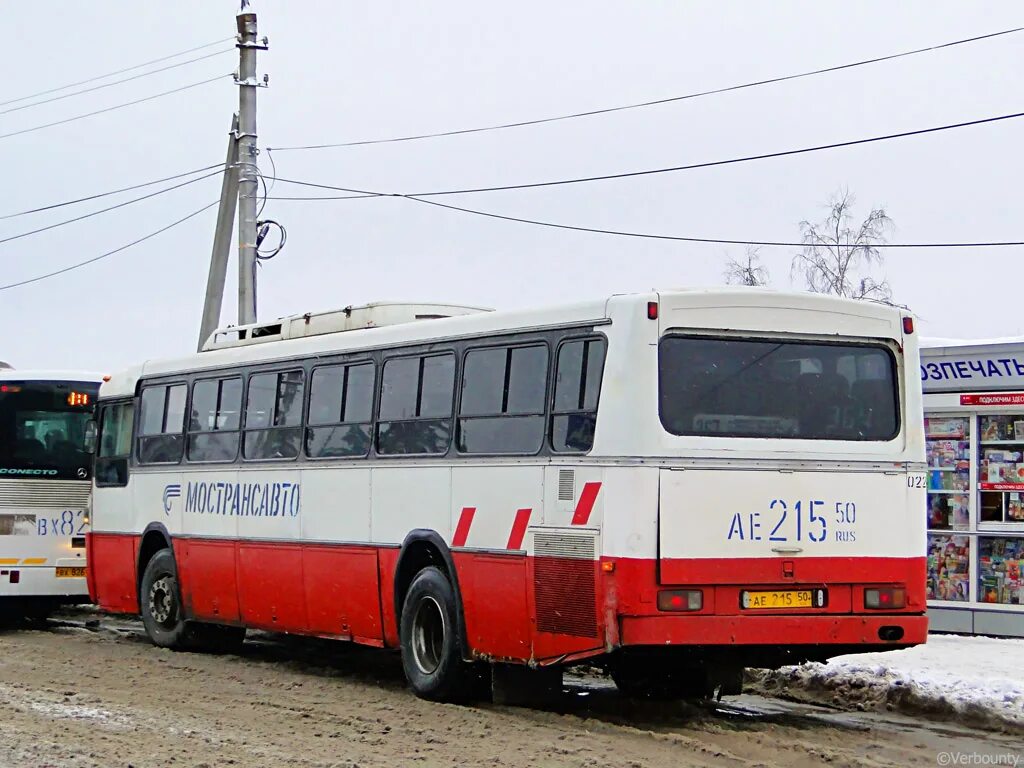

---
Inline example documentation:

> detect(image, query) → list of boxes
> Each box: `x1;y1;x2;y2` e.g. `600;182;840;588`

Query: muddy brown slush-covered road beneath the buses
0;611;1019;768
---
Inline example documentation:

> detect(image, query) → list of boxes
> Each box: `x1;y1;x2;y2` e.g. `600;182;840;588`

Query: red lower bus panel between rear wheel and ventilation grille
455;552;531;662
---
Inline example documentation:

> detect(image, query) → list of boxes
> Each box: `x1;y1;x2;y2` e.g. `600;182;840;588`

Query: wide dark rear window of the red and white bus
658;336;899;440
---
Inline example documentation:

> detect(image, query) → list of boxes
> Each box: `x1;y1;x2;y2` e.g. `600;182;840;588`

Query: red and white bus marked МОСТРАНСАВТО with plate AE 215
89;289;927;699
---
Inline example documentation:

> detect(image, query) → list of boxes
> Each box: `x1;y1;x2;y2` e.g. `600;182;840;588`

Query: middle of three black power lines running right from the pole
268;112;1024;200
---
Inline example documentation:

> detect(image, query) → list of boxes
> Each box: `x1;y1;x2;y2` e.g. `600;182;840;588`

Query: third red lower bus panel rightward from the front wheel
302;546;384;645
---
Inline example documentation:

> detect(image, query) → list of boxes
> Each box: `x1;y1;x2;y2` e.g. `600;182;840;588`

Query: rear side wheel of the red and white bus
398;566;472;701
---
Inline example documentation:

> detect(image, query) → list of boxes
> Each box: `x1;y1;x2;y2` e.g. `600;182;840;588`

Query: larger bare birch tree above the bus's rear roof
793;189;893;302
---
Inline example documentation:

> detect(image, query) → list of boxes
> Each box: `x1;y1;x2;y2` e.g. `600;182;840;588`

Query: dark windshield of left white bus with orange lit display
0;381;99;480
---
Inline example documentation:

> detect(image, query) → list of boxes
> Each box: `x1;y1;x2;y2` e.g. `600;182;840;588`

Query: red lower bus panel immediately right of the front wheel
174;538;241;623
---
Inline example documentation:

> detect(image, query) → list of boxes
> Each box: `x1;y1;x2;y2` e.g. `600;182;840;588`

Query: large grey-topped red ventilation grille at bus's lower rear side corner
534;532;597;637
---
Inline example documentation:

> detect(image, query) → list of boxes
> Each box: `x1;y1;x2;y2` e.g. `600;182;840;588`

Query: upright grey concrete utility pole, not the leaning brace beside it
236;0;267;325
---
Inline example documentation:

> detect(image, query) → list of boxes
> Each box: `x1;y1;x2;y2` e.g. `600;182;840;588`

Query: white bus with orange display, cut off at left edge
0;368;100;616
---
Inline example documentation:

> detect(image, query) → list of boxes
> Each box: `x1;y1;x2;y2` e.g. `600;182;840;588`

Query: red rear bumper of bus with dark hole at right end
620;613;928;650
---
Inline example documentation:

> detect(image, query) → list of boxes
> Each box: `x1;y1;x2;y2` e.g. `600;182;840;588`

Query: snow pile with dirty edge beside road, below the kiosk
755;635;1024;730
